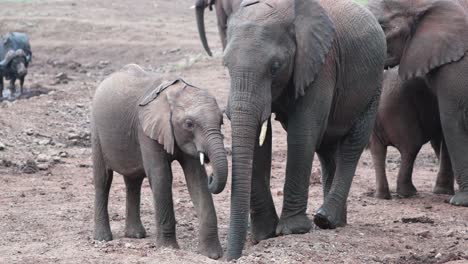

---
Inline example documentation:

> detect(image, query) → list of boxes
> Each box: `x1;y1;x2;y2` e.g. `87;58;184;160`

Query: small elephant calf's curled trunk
207;130;228;194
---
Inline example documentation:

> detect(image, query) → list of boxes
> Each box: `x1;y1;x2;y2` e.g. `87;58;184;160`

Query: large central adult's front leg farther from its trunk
276;83;333;235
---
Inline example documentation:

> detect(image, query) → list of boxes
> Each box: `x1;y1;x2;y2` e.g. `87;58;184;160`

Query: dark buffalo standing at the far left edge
0;32;32;97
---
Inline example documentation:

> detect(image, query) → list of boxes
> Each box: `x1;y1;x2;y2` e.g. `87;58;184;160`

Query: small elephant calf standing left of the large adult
92;64;228;259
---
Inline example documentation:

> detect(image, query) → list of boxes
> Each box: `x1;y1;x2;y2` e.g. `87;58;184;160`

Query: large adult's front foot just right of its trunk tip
251;213;278;243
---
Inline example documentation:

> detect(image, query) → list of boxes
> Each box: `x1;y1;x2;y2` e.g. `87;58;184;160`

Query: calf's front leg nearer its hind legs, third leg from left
139;131;179;248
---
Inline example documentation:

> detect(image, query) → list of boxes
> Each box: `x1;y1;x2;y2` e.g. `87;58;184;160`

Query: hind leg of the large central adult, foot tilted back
314;96;379;229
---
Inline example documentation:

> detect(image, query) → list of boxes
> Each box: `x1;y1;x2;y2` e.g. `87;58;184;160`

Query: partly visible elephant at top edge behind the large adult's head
195;0;242;56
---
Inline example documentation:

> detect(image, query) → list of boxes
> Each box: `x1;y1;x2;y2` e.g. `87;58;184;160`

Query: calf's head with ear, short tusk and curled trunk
139;79;228;194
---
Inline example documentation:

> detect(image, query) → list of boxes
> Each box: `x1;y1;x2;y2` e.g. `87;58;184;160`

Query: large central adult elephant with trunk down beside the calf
224;0;386;259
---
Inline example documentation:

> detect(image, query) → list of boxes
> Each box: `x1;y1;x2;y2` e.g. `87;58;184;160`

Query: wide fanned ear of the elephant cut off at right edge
399;0;468;80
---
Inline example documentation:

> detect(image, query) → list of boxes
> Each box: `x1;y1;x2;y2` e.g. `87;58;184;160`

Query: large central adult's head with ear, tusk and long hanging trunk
223;0;335;259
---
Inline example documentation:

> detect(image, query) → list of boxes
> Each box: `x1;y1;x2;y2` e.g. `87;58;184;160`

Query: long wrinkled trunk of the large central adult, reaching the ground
227;71;271;260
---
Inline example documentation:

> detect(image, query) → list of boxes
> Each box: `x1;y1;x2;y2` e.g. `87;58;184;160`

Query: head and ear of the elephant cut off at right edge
368;0;468;80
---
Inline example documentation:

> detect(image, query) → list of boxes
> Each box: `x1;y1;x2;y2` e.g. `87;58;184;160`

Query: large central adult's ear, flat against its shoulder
294;0;335;98
